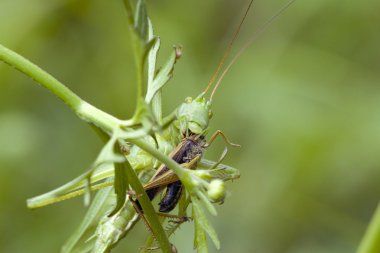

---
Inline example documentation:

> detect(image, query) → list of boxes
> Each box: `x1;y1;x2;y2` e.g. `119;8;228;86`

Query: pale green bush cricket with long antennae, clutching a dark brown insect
22;0;294;253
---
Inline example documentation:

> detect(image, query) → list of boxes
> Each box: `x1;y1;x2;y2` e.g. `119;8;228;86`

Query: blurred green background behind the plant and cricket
0;0;380;253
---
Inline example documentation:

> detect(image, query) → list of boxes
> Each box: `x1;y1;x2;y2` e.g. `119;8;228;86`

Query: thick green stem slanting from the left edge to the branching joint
0;44;120;133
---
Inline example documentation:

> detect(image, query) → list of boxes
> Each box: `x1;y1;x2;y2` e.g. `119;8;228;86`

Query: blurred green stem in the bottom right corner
357;203;380;253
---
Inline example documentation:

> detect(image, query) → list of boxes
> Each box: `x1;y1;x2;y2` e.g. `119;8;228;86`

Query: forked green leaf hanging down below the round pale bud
192;198;220;252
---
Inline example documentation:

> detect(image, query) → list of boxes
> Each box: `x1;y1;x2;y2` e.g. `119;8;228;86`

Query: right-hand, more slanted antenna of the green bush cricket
210;0;296;101
